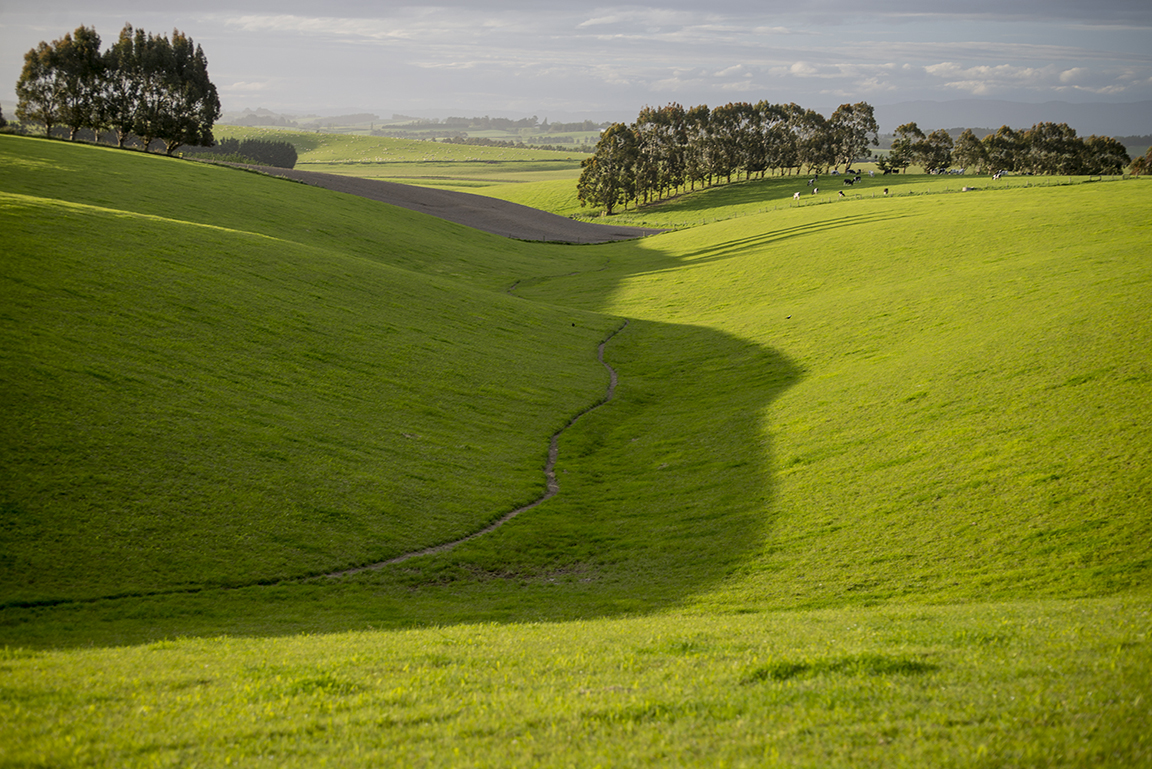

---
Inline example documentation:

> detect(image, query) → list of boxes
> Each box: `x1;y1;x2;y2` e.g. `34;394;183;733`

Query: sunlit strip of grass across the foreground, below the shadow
0;599;1152;767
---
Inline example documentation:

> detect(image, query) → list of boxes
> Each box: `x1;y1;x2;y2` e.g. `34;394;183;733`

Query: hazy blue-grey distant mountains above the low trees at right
874;99;1152;136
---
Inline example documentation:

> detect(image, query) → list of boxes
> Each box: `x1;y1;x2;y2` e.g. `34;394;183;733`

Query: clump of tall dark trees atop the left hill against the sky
16;24;220;154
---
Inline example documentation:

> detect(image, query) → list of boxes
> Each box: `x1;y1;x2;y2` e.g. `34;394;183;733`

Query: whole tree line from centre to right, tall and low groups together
577;101;1149;215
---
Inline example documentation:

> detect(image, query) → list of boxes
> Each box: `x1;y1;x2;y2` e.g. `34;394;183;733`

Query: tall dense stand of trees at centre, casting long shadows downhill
577;101;879;215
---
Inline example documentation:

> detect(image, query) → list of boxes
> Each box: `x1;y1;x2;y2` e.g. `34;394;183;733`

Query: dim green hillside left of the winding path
0;139;617;603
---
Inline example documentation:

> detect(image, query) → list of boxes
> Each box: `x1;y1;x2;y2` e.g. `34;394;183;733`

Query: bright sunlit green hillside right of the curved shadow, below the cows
524;182;1152;608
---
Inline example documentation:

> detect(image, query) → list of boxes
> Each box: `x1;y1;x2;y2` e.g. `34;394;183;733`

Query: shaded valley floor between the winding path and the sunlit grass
0;320;801;647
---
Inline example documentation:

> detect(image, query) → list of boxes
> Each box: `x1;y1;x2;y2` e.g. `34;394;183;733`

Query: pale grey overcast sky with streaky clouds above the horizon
0;0;1152;121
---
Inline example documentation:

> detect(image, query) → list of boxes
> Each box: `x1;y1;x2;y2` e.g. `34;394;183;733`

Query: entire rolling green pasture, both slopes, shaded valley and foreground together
0;136;1152;767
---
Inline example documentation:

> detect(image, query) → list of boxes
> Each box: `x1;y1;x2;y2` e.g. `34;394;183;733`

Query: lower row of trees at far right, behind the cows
879;123;1131;176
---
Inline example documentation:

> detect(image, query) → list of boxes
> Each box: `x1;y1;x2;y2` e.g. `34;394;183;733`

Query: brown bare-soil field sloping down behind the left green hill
245;166;664;243
